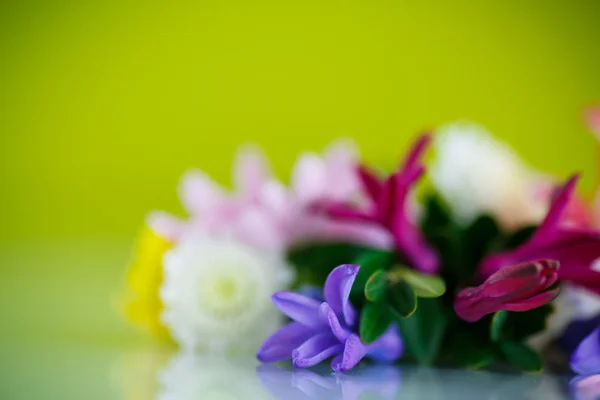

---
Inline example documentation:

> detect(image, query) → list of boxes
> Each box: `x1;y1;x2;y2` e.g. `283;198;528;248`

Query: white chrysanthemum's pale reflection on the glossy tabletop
156;353;266;400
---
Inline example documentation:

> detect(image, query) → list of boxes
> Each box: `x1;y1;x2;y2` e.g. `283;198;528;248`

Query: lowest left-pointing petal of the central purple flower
256;322;315;363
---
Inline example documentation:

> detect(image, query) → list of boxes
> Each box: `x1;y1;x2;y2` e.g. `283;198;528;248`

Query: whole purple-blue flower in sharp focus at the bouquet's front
256;264;403;371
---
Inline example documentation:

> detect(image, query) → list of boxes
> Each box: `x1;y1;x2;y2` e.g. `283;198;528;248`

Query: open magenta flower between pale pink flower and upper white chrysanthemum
328;134;439;274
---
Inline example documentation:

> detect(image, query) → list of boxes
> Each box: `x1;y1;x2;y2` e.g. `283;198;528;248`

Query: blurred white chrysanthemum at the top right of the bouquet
430;122;547;229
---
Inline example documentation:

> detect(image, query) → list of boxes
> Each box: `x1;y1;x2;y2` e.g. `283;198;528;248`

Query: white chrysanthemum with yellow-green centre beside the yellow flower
160;236;292;352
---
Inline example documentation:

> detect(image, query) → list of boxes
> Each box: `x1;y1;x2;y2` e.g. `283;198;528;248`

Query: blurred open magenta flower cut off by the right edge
480;175;600;293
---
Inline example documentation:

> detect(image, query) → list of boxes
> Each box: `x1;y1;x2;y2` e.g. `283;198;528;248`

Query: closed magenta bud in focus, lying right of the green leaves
454;260;559;322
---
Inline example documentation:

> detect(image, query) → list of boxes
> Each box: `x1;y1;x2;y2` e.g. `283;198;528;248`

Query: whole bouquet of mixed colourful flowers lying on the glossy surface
119;114;600;372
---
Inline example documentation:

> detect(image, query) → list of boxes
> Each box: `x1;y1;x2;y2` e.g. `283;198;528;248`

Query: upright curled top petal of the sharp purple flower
325;264;360;327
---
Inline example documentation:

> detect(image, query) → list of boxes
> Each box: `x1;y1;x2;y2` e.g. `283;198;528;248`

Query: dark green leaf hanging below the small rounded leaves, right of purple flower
396;299;448;365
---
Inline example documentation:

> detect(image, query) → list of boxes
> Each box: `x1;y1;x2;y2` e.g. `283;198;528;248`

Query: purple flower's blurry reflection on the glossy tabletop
256;365;402;400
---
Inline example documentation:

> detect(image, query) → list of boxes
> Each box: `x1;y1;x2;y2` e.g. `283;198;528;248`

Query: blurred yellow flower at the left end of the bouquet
123;226;172;340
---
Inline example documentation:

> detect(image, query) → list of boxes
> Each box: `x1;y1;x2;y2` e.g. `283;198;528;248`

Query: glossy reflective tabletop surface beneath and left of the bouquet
0;239;576;400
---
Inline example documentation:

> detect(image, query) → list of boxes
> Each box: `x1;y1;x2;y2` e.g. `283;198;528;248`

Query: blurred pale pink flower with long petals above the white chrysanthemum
148;142;390;249
